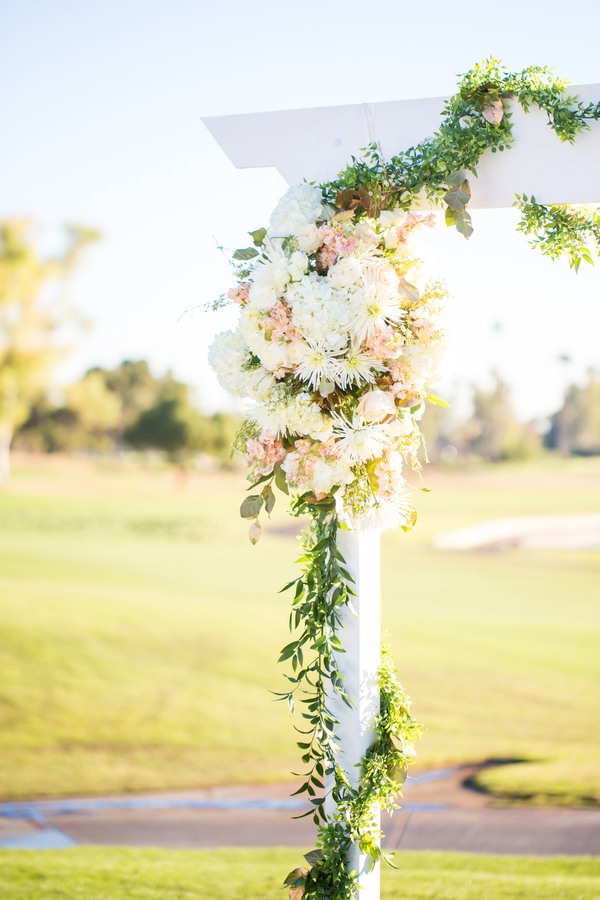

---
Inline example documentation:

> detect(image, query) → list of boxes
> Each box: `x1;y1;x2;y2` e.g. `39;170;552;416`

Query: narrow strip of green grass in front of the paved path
0;848;600;900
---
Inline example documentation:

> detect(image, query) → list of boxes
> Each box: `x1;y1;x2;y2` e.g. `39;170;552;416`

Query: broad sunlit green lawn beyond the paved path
0;460;600;804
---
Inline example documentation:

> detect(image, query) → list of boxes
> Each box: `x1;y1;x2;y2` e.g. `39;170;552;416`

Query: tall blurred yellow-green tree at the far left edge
0;219;98;483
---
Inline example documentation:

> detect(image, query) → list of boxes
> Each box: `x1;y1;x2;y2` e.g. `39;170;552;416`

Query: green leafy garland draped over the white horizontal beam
322;59;600;270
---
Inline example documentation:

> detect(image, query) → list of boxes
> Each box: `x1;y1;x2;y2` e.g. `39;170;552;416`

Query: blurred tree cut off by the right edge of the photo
544;372;600;456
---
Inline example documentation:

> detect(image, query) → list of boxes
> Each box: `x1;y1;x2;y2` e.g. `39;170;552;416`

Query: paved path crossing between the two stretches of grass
0;767;600;855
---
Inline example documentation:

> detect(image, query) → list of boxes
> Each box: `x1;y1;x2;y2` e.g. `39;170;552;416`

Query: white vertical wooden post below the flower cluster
325;530;381;900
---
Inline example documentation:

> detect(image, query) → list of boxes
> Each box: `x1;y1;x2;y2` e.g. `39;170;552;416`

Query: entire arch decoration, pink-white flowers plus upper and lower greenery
210;59;600;900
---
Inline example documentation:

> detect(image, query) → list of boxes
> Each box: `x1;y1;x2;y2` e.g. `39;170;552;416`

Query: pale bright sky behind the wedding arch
0;0;600;417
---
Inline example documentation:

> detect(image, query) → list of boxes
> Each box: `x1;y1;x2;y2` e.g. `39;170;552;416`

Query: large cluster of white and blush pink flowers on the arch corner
210;184;445;542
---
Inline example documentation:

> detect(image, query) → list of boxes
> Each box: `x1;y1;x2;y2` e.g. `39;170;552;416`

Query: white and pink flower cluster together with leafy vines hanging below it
210;184;446;900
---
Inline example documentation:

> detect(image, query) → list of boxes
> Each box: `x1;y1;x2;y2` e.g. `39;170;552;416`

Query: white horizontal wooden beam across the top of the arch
202;84;600;209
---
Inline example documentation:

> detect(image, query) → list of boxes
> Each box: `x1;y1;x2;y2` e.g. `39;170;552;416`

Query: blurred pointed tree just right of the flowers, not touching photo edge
453;373;542;462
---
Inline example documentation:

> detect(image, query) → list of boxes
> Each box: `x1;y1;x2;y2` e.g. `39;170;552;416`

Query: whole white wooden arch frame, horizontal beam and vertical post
203;84;600;900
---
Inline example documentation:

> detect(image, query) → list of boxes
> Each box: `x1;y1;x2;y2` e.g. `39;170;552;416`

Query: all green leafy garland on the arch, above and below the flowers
243;59;600;900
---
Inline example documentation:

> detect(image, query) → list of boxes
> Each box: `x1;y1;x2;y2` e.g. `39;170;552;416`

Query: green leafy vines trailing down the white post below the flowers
277;510;421;900
